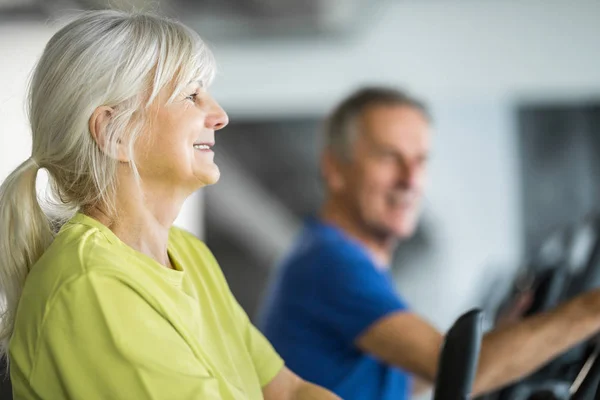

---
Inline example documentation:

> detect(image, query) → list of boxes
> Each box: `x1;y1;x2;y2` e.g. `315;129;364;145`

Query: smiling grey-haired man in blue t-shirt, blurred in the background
259;87;600;400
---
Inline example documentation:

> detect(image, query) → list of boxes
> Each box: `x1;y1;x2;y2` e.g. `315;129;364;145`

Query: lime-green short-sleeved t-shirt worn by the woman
9;214;283;400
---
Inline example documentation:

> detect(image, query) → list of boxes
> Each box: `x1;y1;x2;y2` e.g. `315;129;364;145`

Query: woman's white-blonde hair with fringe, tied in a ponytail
0;10;215;357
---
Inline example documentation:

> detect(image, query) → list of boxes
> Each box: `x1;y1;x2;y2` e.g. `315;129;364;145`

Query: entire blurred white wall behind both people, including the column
0;0;600;328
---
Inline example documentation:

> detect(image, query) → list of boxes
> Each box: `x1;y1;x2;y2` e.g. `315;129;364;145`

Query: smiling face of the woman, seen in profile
135;82;229;194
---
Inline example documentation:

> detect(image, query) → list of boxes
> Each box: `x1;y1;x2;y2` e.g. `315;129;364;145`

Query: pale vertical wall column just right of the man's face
397;99;522;329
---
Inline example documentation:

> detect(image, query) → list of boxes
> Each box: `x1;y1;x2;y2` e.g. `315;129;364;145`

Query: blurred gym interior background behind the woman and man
0;0;600;354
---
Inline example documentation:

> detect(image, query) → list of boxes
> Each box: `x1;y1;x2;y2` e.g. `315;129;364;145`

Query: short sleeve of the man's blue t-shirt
300;245;407;344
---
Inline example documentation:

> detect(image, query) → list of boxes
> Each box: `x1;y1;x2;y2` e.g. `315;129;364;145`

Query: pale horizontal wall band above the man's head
211;0;600;113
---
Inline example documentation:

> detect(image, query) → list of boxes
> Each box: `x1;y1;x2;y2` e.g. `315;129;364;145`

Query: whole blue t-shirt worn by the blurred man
258;220;411;400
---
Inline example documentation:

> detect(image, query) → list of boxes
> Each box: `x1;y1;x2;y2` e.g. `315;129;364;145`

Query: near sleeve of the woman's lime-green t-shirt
30;272;220;400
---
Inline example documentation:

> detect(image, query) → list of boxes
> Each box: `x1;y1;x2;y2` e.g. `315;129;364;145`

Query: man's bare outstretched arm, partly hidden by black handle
356;291;600;395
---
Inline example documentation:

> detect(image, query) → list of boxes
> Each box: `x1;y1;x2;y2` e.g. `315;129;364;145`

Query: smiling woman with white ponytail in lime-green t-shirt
0;11;336;400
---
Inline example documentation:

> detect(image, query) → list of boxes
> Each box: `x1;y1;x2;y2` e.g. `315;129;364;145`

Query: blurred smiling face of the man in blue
332;105;430;239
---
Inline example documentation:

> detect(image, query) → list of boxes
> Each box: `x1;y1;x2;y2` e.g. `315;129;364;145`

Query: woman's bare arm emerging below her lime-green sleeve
263;367;339;400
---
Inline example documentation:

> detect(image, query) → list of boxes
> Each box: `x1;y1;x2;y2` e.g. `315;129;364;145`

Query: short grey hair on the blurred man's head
324;86;431;161
